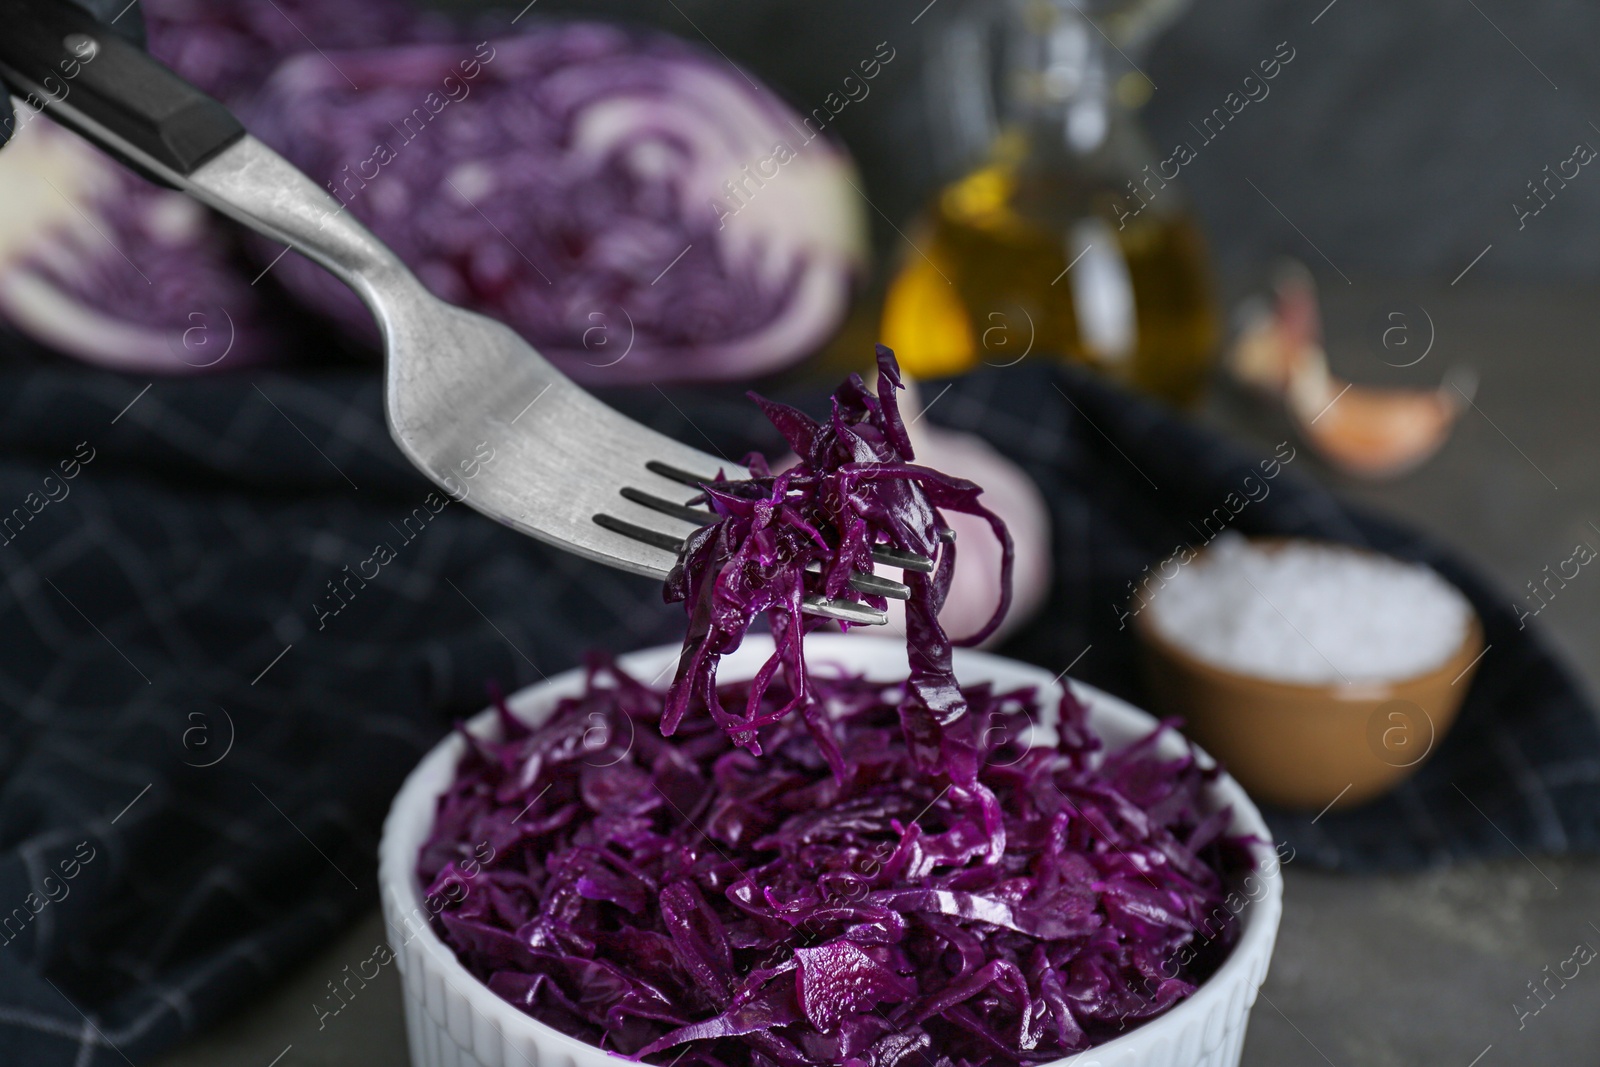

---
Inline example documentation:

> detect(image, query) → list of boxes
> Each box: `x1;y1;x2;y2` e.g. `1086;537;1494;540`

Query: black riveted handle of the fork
0;0;245;184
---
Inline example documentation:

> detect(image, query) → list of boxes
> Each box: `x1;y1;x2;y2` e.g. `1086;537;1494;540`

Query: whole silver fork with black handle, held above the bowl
0;0;933;624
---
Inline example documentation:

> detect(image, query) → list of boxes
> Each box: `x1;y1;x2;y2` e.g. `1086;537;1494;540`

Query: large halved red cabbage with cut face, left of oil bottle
246;22;864;384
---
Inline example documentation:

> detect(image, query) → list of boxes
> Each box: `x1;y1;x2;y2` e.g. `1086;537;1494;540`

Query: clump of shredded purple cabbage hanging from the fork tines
661;346;1013;787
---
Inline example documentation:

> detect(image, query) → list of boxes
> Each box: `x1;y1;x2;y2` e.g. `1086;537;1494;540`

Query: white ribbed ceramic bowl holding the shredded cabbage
379;633;1283;1067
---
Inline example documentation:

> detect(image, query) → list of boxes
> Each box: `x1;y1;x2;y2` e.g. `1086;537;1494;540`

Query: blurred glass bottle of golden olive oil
882;0;1219;405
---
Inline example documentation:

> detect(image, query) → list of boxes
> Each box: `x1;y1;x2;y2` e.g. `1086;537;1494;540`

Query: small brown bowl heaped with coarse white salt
1130;534;1485;811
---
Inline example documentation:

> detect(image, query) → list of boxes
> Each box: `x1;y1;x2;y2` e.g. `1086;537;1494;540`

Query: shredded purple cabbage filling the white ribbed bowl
418;661;1248;1067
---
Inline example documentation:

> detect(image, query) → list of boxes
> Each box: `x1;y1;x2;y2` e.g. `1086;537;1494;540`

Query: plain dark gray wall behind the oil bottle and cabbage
508;0;1600;283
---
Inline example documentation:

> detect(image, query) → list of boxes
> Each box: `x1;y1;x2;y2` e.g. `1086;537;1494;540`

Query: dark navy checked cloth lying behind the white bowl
0;366;1600;1067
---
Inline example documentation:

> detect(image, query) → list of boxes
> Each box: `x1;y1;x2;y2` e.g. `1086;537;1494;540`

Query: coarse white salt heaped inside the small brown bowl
1142;533;1472;685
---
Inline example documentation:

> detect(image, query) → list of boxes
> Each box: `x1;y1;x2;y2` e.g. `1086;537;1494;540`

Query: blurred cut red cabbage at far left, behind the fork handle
0;0;443;373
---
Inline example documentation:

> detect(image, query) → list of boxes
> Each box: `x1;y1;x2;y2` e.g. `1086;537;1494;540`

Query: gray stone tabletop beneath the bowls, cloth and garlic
155;277;1600;1067
